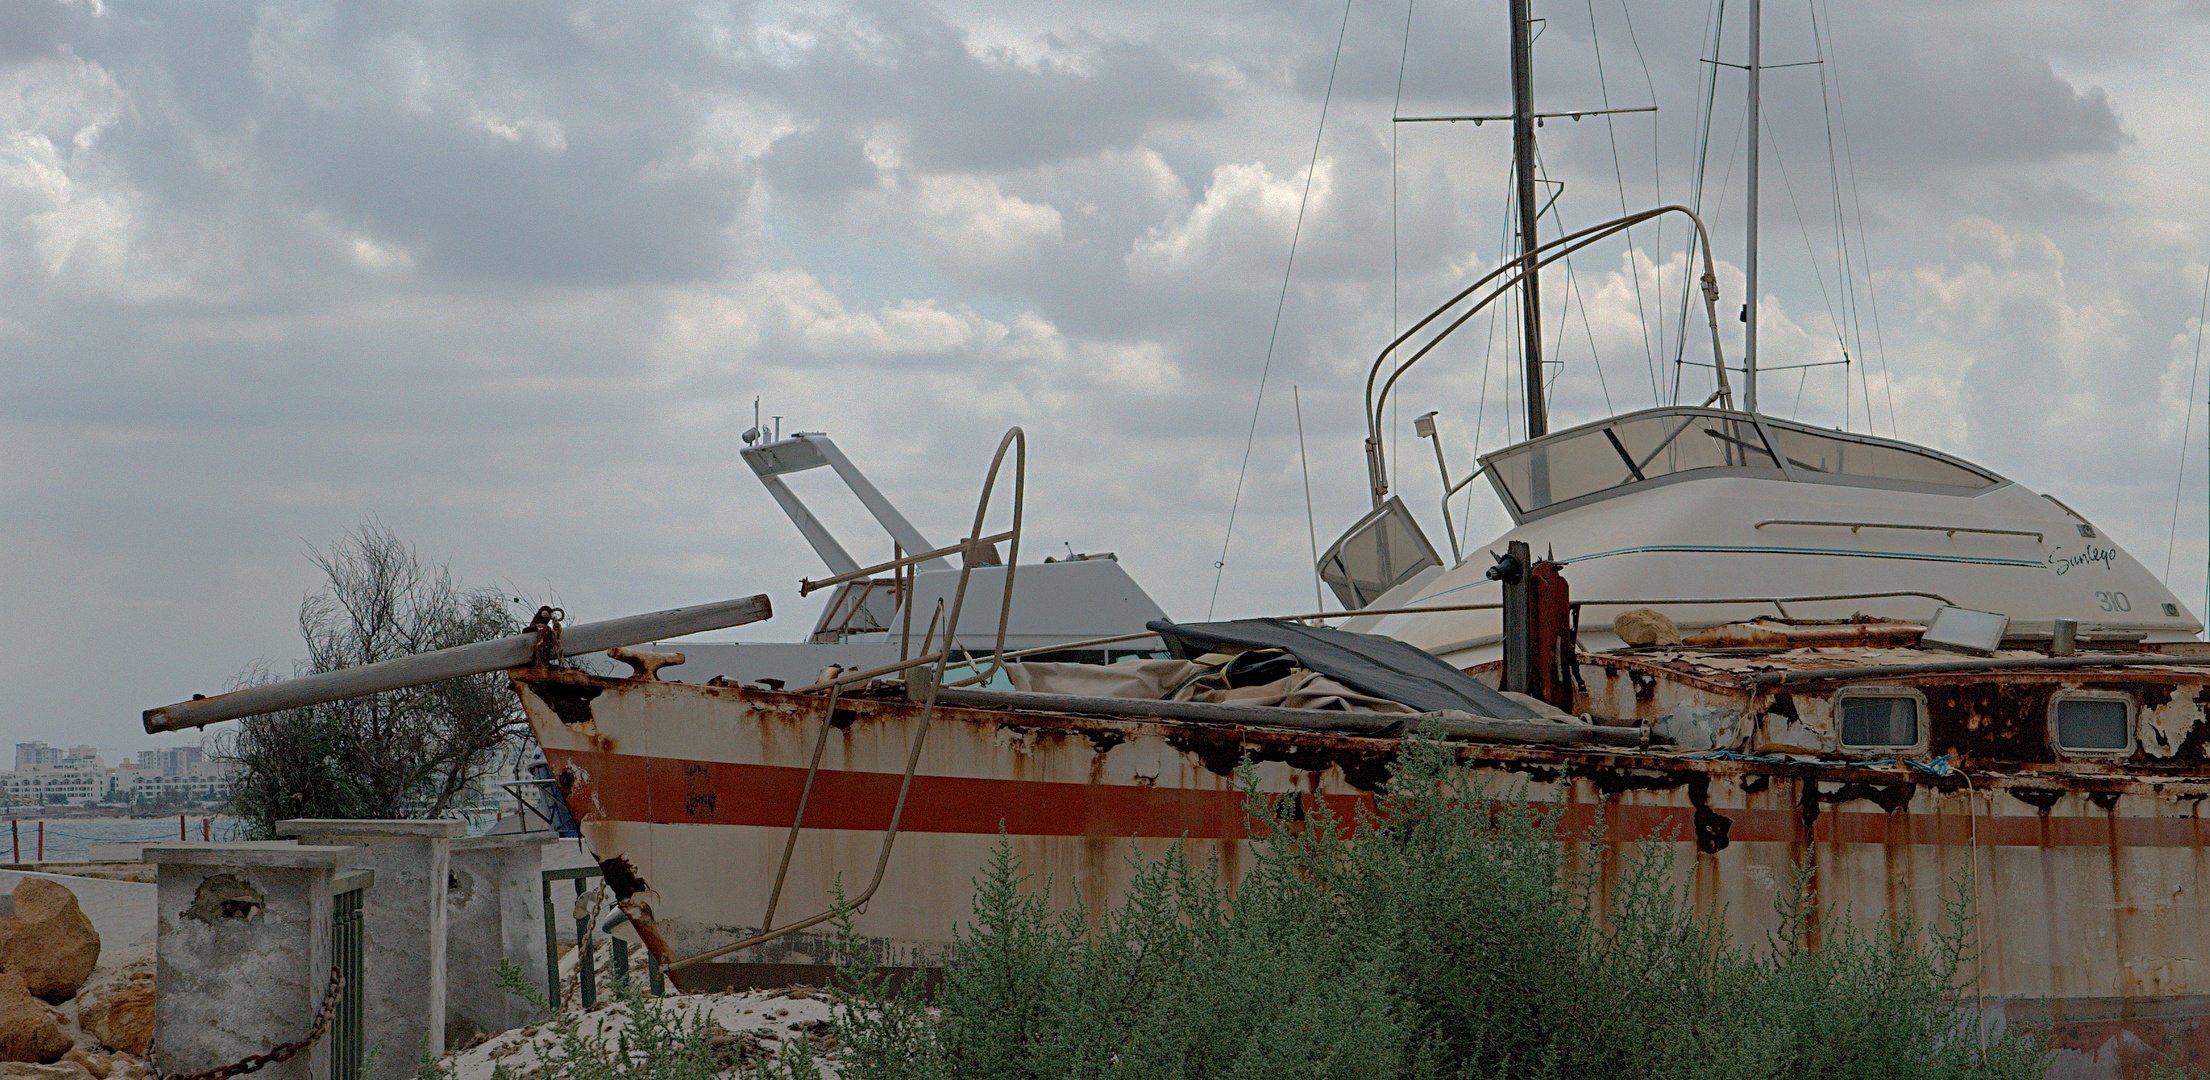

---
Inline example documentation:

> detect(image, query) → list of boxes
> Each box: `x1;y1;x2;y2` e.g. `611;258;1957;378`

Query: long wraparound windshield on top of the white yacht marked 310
1485;409;2000;515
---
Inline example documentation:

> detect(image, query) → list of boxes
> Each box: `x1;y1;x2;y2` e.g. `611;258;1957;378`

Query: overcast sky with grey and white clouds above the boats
0;0;2210;747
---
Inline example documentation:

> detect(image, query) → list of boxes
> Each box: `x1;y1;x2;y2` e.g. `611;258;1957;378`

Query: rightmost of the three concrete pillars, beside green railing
444;833;555;1047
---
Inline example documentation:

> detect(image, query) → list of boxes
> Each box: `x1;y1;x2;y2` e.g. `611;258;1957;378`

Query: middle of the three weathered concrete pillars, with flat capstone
276;817;466;1080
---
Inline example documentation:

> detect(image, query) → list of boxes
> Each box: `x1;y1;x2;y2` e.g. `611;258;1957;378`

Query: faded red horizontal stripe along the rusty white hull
548;751;2210;848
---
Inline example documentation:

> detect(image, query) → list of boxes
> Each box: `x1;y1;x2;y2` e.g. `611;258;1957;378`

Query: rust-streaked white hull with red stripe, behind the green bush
515;658;2210;1076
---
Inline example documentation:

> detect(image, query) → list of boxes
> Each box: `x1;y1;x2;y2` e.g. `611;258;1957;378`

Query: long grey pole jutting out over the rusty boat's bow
146;594;774;733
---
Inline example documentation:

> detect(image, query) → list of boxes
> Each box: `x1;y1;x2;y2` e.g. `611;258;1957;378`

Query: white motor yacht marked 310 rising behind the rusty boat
1324;409;2201;667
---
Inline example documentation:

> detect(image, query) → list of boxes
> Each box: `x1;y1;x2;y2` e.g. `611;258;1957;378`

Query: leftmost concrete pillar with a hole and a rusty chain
144;844;358;1080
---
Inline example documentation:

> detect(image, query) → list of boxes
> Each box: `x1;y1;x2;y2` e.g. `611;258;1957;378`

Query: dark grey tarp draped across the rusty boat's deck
1143;618;1536;720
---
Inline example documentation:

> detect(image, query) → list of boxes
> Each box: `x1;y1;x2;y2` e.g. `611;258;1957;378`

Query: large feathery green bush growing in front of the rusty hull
804;740;2042;1080
